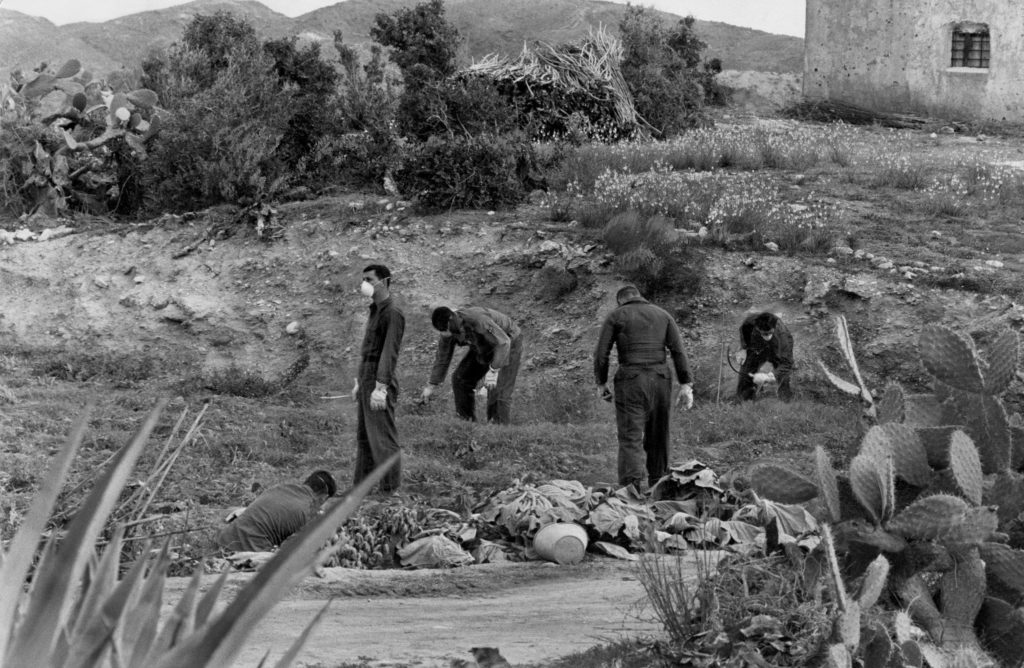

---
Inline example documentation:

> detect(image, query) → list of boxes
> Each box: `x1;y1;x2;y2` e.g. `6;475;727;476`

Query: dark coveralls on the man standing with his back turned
594;297;690;489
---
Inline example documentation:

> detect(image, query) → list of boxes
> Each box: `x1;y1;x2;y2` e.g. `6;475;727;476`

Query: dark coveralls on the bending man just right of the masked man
430;306;522;424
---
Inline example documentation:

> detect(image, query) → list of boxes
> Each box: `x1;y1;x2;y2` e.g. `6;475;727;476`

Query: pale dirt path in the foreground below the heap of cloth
165;556;679;668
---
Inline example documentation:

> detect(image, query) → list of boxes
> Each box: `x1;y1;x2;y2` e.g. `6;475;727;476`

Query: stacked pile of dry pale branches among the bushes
461;27;650;136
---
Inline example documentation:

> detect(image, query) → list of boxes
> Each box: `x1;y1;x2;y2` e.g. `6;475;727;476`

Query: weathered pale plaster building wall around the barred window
803;0;1024;121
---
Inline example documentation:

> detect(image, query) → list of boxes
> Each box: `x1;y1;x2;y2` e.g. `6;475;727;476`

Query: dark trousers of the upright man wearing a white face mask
352;374;401;492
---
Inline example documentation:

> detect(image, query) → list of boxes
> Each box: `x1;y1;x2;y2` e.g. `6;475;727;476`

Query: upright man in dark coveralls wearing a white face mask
352;264;406;493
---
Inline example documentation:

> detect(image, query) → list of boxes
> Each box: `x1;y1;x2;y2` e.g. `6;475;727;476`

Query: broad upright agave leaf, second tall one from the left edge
7;400;167;665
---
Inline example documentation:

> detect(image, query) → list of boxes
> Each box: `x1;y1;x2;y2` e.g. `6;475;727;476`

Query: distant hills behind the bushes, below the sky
0;0;804;76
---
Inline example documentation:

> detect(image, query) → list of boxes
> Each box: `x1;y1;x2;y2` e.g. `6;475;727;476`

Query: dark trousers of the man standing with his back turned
615;364;672;489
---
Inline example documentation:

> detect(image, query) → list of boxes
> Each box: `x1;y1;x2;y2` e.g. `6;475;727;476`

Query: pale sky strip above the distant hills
0;0;805;37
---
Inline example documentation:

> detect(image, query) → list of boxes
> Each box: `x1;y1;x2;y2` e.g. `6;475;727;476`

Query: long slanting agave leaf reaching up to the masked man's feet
155;454;398;668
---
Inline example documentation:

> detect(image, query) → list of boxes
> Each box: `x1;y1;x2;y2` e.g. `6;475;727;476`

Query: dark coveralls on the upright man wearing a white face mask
352;297;406;492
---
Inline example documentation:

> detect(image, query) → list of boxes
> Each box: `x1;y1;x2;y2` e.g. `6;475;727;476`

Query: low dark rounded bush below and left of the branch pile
395;134;534;211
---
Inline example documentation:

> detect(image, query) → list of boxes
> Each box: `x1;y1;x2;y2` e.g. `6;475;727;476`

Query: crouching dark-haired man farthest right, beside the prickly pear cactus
736;311;793;402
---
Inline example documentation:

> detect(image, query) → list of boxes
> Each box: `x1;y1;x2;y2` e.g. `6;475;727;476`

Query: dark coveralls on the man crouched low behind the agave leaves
217;483;319;552
